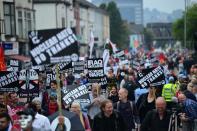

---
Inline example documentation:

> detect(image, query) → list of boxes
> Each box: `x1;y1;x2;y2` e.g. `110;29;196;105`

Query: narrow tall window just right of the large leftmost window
18;10;23;38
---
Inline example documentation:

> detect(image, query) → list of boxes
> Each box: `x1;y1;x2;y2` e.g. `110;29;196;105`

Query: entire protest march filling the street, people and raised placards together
0;28;197;131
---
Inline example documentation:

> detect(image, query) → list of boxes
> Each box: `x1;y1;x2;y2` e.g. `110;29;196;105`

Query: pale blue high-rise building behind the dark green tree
92;0;143;25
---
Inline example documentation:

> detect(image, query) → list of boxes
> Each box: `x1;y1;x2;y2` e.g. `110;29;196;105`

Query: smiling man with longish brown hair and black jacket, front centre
92;99;126;131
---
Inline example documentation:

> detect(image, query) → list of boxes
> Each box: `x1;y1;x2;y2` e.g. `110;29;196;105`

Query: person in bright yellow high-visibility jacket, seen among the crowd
162;76;176;109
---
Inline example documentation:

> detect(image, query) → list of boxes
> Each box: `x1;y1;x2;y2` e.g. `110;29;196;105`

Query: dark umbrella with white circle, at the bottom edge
48;110;85;131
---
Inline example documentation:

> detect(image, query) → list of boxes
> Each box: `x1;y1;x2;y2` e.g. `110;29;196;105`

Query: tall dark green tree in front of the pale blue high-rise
100;1;129;48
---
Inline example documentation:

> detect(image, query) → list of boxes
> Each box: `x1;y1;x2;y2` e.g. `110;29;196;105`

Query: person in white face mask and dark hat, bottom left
17;108;36;131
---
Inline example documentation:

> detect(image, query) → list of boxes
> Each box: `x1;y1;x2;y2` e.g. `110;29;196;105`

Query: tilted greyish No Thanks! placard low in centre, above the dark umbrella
62;85;90;105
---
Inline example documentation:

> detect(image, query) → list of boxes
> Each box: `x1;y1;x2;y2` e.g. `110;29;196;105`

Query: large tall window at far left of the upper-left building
4;3;16;36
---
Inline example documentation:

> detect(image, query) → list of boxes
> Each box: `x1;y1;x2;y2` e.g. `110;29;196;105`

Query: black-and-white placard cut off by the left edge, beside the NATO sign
0;71;19;92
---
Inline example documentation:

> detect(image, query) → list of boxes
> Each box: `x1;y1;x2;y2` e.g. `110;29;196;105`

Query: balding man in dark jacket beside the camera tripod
140;97;170;131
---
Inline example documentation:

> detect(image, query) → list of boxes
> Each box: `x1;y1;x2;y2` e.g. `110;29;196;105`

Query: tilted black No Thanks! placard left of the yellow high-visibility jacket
138;66;165;88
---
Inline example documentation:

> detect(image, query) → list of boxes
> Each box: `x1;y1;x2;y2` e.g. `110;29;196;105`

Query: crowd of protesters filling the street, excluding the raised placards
0;48;197;131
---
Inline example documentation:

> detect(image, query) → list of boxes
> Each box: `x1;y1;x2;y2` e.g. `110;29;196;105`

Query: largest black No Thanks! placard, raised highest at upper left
28;28;79;65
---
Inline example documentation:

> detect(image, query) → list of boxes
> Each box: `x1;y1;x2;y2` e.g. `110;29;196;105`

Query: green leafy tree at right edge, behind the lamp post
173;4;197;47
